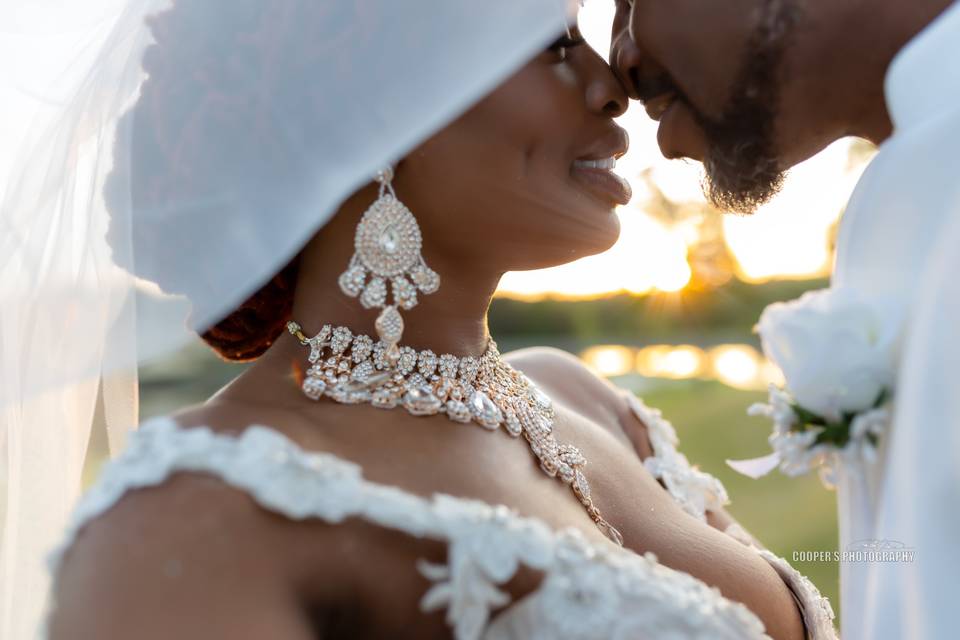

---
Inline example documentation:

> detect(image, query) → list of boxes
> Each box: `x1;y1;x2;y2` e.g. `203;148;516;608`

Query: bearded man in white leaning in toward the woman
610;0;960;640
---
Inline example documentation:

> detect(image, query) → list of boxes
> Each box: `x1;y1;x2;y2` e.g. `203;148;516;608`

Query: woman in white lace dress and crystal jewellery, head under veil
1;0;834;640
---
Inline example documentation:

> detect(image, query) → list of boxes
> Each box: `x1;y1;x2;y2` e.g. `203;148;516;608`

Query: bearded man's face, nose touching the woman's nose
610;0;800;213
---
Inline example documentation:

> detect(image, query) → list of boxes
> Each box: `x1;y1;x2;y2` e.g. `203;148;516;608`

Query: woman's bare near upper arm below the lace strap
48;464;326;640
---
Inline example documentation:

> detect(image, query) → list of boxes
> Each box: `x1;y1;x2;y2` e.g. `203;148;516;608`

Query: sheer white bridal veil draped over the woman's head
0;0;579;640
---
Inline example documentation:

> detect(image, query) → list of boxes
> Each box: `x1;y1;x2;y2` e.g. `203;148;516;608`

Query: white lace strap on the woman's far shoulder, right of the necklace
623;392;730;522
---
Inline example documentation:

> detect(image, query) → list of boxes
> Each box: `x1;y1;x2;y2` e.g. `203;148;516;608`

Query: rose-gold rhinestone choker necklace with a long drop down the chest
287;322;623;546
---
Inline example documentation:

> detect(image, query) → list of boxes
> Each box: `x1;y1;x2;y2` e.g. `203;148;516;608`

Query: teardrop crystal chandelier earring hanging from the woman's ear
339;167;440;368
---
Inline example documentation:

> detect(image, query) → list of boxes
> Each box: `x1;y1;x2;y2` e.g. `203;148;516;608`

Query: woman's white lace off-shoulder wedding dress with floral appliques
42;394;836;640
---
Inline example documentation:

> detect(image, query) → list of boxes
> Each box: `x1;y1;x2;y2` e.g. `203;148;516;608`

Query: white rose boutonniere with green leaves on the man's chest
727;289;902;486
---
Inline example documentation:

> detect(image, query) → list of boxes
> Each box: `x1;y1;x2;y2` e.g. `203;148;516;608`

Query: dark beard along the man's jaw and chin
695;0;799;213
